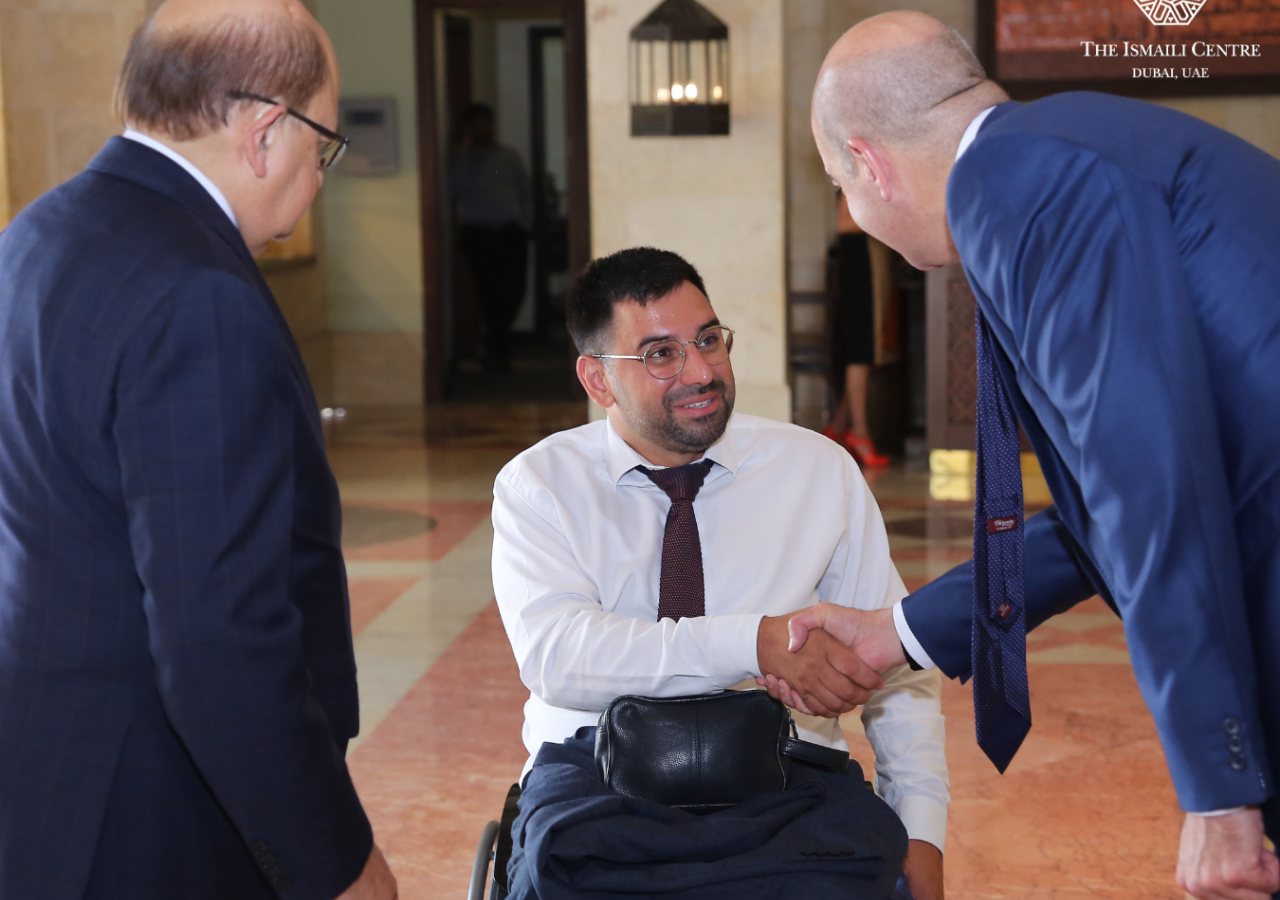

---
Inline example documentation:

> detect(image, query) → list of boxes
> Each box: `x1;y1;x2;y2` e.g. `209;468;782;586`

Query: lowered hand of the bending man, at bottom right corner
1178;807;1280;900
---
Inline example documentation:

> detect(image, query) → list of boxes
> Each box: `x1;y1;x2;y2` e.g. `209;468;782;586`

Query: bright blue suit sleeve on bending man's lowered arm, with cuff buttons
947;133;1270;812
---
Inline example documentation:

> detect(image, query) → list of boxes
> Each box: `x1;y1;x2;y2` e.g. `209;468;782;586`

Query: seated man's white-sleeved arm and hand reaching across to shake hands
493;474;879;714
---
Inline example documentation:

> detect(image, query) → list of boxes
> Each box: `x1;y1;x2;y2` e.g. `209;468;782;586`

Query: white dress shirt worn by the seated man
493;415;950;849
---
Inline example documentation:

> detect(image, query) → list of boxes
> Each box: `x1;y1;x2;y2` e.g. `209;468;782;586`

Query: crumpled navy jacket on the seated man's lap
507;728;906;900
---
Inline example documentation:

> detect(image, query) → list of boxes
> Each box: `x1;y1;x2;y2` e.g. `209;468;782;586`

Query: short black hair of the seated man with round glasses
564;247;707;355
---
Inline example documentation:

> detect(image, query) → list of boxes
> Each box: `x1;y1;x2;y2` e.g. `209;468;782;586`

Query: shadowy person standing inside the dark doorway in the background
449;104;534;371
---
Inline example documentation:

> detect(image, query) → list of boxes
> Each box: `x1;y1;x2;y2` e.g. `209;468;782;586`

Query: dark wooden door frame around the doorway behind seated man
413;0;591;405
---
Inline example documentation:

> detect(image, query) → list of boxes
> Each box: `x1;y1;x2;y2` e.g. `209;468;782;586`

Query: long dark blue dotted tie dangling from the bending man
972;310;1032;772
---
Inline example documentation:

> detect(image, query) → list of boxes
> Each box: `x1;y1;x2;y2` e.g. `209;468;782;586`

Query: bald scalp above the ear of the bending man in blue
813;12;1006;165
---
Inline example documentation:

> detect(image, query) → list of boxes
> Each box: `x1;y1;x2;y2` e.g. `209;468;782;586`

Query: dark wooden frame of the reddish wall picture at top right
975;0;1280;100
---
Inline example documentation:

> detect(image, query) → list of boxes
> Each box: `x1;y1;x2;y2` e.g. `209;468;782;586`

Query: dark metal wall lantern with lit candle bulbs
628;0;728;137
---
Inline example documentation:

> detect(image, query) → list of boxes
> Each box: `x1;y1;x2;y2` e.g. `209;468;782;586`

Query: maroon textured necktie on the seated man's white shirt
637;460;712;621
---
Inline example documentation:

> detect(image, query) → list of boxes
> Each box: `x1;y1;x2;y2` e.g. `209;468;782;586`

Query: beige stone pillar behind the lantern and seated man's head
586;0;791;421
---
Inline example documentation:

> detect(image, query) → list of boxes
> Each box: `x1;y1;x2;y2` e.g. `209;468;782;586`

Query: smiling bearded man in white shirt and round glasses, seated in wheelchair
493;247;948;900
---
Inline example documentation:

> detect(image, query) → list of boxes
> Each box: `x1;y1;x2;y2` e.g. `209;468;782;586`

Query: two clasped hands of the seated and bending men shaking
755;603;906;718
